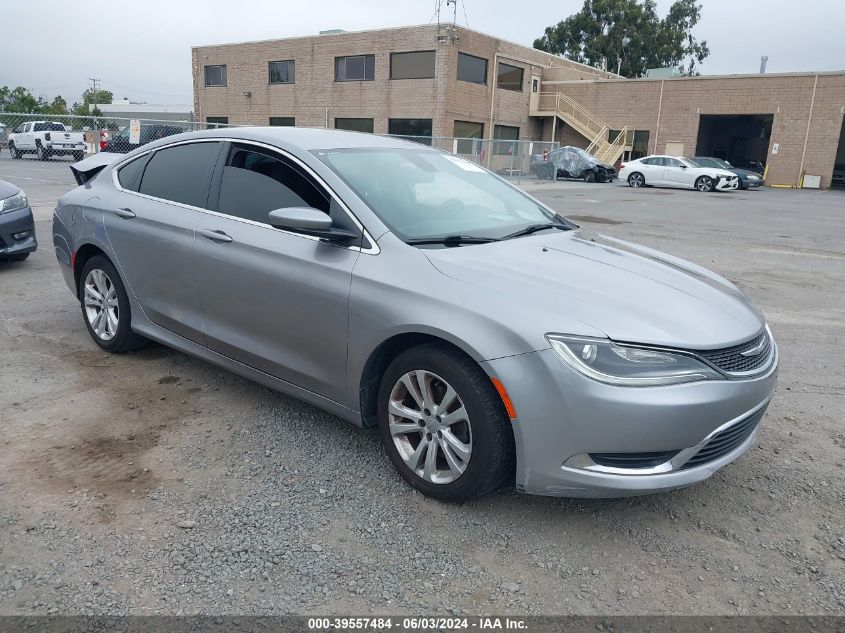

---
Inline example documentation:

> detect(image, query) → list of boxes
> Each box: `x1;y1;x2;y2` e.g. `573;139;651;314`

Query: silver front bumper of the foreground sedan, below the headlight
484;338;777;497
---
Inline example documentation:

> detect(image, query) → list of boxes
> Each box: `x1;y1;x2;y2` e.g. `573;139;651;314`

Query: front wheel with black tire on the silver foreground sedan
377;343;514;501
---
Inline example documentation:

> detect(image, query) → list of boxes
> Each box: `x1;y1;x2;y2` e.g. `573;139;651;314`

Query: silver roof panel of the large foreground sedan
139;127;429;152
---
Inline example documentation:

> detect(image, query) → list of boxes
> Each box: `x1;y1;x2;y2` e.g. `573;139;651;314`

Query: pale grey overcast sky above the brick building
0;0;845;104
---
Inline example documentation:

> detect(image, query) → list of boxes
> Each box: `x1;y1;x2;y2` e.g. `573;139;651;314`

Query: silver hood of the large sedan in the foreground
424;230;765;349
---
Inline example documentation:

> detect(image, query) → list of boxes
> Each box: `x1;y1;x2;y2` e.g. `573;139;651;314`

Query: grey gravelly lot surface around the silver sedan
0;155;845;614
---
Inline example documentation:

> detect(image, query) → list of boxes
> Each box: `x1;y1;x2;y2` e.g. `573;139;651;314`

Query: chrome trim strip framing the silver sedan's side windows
111;136;381;255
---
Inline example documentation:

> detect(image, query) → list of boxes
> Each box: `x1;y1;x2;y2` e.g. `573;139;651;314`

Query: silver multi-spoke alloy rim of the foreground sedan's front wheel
387;369;472;484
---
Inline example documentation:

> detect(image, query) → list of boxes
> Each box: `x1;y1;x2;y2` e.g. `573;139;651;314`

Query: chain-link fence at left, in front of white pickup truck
0;112;231;160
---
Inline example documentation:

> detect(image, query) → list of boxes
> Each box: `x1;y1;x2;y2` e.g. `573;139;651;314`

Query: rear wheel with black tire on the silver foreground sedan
79;255;147;354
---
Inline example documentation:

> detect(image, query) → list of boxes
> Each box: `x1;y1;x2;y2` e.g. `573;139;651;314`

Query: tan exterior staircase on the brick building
530;92;634;165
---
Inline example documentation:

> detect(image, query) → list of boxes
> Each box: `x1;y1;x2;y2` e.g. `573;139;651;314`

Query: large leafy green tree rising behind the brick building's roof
534;0;710;77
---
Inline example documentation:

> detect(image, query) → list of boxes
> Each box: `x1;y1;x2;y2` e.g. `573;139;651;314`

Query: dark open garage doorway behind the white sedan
695;114;774;171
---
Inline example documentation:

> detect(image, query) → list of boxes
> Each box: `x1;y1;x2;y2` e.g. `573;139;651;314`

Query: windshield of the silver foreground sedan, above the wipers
314;148;569;241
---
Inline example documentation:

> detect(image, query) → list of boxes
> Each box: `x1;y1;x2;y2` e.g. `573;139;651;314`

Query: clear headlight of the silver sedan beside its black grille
546;334;724;387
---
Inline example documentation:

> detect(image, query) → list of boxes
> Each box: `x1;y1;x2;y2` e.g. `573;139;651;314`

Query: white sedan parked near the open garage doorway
619;156;739;191
